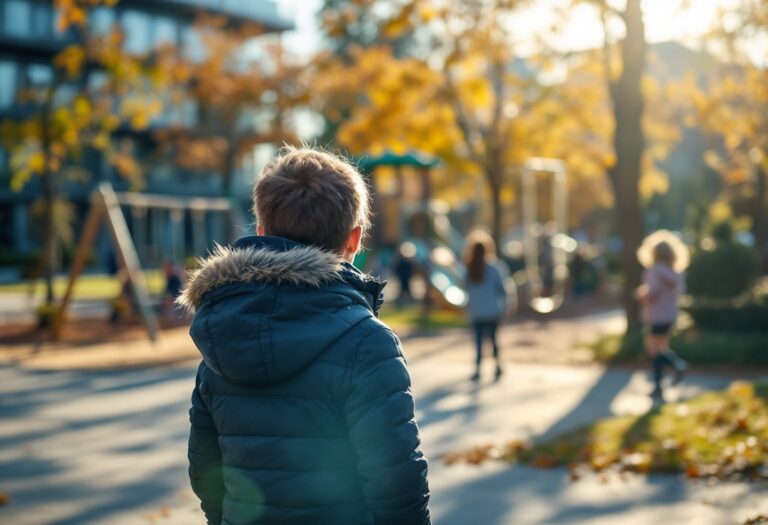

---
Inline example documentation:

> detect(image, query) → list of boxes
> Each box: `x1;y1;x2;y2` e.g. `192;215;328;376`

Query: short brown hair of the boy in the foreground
253;147;369;252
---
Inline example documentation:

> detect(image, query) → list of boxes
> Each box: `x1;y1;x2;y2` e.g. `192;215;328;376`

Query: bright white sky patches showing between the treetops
277;0;752;56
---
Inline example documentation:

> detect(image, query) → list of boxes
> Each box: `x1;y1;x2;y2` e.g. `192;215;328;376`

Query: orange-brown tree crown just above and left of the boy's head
155;14;306;201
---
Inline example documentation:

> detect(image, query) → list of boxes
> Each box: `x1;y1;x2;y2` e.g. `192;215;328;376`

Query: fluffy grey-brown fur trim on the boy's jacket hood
176;237;342;311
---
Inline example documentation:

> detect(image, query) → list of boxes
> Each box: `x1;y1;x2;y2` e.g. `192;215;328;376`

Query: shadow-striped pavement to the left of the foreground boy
0;367;194;525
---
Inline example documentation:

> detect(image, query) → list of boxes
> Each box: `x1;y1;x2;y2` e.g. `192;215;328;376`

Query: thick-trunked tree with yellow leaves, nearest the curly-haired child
566;0;676;330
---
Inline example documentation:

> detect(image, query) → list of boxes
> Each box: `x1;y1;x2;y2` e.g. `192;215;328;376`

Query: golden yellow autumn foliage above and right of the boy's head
313;2;680;229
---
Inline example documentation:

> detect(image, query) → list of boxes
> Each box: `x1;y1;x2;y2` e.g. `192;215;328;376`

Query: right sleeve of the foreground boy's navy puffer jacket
344;327;431;525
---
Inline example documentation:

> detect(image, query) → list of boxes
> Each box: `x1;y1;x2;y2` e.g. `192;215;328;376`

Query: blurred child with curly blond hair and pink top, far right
635;230;689;401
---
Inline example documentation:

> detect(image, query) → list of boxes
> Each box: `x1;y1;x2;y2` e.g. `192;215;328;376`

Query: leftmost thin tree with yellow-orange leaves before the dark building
0;0;170;316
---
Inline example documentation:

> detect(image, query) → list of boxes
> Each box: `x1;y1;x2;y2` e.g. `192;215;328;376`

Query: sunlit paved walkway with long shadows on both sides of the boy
0;314;768;525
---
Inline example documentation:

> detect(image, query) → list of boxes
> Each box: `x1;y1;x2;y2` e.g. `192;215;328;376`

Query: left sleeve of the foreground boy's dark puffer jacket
188;363;224;525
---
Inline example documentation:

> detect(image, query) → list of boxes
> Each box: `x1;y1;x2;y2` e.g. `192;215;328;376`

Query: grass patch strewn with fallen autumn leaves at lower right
444;381;768;480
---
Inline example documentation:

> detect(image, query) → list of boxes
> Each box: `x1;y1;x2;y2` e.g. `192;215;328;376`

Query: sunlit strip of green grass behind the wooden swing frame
0;270;165;300
